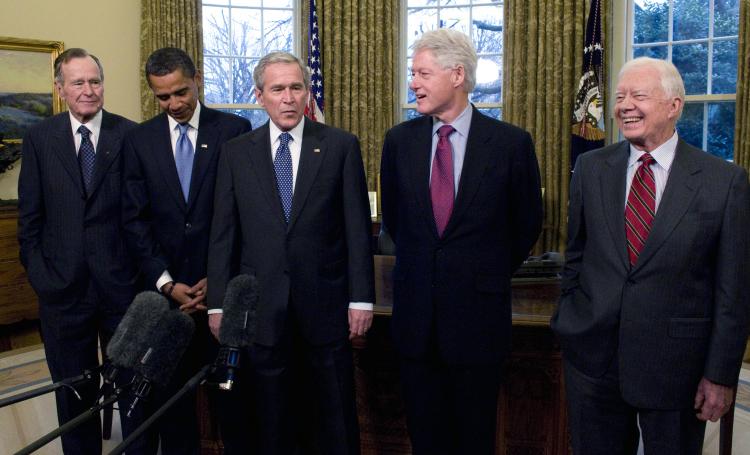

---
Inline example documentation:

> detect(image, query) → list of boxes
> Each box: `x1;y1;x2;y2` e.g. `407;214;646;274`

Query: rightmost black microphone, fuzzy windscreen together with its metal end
208;274;258;390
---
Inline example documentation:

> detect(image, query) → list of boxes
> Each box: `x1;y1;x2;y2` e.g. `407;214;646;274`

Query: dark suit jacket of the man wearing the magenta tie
380;108;542;364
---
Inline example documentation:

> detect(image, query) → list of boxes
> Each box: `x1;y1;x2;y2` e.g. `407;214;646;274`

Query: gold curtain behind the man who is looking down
139;0;203;120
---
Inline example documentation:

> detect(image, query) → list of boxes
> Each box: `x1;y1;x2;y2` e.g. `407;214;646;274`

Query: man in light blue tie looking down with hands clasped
122;47;251;455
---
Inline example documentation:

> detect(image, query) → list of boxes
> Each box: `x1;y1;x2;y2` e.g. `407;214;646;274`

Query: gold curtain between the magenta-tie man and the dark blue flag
503;0;609;252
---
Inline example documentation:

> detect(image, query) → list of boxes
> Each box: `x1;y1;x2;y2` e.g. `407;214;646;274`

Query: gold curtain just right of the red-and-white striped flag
302;0;399;191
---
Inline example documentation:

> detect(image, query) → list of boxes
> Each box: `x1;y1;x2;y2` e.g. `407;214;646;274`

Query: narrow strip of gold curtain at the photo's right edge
734;0;750;173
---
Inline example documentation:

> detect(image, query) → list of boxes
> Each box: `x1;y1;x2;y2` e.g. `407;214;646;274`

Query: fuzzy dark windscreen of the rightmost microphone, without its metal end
219;274;258;347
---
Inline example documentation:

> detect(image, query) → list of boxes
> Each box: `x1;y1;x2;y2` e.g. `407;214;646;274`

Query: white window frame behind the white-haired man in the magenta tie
398;0;505;122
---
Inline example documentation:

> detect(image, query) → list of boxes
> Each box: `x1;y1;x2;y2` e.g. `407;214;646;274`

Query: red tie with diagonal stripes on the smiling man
625;153;656;266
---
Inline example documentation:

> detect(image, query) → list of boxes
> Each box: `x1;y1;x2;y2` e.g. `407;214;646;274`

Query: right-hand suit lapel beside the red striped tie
633;139;703;272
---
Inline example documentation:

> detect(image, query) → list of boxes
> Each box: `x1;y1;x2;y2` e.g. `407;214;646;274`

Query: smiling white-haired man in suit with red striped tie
552;57;750;455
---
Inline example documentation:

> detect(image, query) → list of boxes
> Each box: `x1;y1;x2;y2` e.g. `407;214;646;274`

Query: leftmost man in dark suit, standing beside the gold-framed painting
18;48;136;454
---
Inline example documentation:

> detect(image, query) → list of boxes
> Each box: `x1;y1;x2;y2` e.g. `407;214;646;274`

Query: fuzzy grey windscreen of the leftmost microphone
107;291;169;368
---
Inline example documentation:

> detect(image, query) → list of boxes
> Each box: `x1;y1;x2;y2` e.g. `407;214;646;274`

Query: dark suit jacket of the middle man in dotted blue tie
208;119;374;346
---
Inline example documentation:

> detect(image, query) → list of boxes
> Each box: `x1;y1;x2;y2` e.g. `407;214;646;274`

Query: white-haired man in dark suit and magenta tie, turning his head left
380;29;542;455
